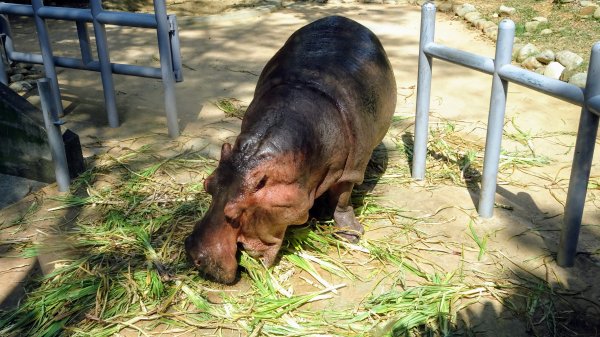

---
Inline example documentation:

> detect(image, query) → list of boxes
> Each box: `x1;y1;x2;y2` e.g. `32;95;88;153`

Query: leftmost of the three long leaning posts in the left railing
31;0;63;116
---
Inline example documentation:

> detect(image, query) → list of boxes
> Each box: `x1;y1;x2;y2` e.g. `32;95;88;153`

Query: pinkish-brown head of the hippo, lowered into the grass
185;142;312;283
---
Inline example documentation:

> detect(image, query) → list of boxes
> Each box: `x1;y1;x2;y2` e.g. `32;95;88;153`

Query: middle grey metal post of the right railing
478;20;515;218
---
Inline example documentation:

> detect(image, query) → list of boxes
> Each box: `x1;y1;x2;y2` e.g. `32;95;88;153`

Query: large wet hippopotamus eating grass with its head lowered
185;16;396;284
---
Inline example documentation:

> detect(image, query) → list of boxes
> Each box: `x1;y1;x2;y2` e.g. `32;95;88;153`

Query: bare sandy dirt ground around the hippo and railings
0;3;600;336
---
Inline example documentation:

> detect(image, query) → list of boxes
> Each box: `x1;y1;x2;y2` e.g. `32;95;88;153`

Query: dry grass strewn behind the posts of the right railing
382;115;555;187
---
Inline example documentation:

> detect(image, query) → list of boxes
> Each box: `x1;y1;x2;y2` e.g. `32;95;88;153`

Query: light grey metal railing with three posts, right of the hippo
412;3;600;266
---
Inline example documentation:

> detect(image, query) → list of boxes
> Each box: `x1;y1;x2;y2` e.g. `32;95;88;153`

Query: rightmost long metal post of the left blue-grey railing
154;0;179;138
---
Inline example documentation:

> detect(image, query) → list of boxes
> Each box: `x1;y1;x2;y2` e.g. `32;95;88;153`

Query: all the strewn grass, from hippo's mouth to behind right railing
0;111;584;336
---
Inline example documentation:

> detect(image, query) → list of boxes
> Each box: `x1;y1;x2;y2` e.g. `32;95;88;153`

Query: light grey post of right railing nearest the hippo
412;2;435;180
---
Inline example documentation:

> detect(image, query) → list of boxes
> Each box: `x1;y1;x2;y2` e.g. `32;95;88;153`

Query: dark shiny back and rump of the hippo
254;16;396;182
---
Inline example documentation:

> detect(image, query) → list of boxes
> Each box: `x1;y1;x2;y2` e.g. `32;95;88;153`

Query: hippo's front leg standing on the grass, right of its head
329;181;365;243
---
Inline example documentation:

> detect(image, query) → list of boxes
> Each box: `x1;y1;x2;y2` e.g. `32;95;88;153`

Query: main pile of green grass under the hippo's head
0;140;504;336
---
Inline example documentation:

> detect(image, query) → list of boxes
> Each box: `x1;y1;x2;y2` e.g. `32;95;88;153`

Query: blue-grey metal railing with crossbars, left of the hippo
0;0;183;137
